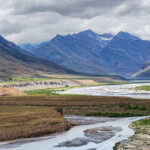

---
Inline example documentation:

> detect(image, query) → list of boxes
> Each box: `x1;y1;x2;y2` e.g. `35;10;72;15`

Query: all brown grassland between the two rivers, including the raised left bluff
0;95;150;141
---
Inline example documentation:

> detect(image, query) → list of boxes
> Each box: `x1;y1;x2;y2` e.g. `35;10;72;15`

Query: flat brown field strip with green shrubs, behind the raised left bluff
0;95;150;117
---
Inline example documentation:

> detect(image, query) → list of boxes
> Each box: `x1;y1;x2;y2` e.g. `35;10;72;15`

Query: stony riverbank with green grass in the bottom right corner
116;118;150;150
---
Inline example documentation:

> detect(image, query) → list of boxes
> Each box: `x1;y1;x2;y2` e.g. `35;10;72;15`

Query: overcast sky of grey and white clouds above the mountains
0;0;150;44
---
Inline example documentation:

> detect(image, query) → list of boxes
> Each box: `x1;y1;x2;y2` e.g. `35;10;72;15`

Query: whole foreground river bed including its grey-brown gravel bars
0;116;148;150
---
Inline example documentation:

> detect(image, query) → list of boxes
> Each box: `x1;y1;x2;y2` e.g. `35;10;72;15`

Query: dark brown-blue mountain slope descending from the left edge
0;36;73;76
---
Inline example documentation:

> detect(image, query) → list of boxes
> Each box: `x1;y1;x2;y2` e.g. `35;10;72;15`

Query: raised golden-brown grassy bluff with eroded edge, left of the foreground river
0;106;68;141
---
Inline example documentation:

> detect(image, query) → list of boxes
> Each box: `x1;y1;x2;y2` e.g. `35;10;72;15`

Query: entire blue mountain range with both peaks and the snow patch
19;30;150;77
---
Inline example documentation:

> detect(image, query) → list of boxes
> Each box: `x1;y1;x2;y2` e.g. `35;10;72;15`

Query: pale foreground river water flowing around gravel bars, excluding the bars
0;116;148;150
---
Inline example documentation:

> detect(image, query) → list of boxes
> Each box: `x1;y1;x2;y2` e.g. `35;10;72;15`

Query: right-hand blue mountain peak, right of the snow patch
97;32;150;77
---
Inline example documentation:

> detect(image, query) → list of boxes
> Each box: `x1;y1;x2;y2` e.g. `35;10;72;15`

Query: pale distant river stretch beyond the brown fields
58;83;150;99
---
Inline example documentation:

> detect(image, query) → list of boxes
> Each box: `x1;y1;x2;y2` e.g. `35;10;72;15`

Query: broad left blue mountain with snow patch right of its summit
19;30;113;74
